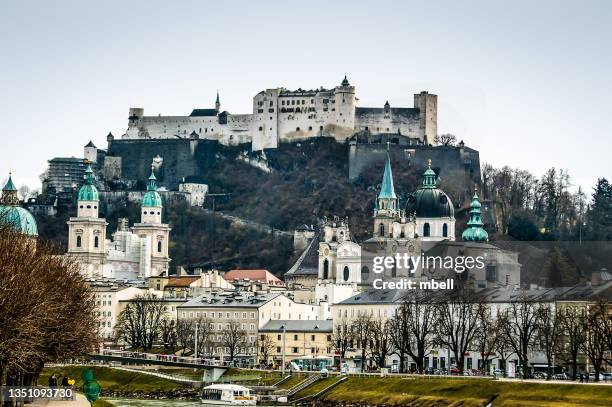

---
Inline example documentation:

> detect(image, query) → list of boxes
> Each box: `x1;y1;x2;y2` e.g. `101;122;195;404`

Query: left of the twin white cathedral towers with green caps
68;165;108;277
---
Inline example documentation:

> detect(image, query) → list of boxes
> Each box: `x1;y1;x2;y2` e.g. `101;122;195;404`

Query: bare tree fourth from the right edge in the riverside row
498;294;538;378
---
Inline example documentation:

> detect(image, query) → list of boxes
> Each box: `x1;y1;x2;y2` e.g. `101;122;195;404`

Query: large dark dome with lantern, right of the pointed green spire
406;160;455;218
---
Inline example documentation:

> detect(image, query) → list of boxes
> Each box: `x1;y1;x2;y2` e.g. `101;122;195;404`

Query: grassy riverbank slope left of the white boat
38;366;190;392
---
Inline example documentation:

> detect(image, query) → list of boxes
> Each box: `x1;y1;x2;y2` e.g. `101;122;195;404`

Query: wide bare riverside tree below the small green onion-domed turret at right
435;288;484;372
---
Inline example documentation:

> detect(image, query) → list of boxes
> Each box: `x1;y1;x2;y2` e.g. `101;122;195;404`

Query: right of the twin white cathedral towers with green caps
133;168;170;278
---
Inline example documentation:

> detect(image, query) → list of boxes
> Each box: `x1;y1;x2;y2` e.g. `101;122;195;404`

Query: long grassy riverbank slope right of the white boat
320;377;612;407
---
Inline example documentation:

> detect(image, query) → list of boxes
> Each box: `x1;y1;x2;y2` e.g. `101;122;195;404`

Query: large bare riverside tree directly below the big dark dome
391;291;436;372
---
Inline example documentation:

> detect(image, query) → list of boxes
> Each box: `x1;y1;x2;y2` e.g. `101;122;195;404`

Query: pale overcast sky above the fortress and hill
0;0;612;192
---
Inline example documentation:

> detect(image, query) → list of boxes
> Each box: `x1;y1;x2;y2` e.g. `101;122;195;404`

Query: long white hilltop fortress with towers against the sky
123;76;438;151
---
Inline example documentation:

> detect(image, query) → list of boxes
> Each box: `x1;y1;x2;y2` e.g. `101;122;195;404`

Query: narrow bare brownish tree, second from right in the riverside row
559;305;586;380
